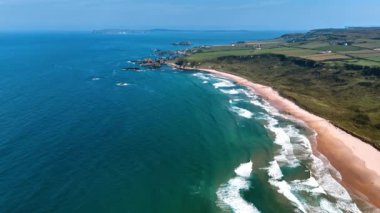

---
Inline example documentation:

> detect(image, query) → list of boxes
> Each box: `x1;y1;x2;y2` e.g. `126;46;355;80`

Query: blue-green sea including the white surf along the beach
0;32;366;212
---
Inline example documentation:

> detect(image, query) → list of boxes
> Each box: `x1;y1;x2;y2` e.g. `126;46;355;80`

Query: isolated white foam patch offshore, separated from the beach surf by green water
216;162;259;213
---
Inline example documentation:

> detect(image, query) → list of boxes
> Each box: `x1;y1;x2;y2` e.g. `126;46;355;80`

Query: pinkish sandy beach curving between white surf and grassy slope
168;63;380;208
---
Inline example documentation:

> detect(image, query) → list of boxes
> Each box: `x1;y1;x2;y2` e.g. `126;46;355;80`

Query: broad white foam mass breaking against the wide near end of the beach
260;103;360;213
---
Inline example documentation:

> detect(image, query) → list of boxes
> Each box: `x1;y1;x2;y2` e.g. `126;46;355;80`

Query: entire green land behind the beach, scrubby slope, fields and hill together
176;28;380;149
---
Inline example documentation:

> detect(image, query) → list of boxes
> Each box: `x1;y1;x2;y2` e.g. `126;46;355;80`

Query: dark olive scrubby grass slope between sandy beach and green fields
176;54;380;149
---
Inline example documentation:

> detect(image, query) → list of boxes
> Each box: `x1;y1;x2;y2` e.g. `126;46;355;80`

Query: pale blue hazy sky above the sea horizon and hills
0;0;380;31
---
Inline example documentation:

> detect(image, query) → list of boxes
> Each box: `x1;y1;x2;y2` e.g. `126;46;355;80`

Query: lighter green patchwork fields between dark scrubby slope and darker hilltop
189;32;380;67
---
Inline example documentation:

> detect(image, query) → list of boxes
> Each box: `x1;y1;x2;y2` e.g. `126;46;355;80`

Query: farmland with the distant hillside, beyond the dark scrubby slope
188;28;380;67
